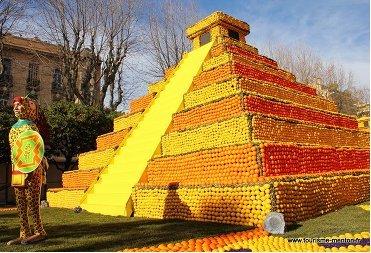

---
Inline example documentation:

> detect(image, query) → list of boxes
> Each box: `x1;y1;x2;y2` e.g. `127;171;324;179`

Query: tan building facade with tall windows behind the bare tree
0;35;63;106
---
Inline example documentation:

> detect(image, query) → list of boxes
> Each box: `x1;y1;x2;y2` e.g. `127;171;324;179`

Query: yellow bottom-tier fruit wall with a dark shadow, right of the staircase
132;184;271;227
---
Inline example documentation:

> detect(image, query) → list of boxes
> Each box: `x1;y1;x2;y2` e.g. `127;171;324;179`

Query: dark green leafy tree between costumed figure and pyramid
45;101;115;168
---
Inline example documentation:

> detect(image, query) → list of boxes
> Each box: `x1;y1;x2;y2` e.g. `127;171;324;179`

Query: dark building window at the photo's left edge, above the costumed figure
0;58;13;106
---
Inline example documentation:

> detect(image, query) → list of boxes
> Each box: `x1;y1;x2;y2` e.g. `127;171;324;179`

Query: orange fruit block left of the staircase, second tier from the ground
62;169;101;188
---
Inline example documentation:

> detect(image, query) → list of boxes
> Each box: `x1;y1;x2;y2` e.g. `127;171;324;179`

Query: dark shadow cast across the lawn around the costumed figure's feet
0;211;247;251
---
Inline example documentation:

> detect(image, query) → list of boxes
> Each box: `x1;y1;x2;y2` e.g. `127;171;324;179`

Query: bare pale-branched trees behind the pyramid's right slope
266;44;369;115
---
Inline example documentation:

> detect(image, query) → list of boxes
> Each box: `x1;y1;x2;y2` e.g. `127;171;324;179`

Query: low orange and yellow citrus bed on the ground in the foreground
123;228;370;252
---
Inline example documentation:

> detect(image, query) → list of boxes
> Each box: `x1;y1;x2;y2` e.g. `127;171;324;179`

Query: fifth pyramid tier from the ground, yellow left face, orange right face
184;77;337;112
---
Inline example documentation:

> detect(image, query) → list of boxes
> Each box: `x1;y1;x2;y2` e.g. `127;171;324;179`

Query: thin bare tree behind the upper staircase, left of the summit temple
143;0;199;78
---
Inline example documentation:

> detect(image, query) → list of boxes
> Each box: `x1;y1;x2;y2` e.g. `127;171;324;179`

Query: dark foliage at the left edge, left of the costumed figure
0;107;17;163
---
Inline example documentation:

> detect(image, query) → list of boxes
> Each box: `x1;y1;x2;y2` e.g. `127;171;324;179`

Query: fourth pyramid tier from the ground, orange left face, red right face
169;93;358;132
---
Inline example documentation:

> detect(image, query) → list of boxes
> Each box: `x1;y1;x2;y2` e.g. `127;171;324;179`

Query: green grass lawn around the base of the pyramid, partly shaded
0;203;370;251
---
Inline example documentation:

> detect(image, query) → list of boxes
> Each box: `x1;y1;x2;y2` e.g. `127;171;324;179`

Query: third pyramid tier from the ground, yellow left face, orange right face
161;114;369;156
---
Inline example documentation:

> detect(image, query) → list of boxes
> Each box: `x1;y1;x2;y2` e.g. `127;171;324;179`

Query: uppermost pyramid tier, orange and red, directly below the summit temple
210;43;280;68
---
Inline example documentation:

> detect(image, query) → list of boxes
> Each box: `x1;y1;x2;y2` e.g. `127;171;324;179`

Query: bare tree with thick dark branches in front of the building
39;0;138;109
